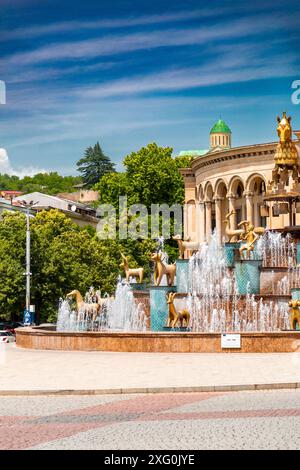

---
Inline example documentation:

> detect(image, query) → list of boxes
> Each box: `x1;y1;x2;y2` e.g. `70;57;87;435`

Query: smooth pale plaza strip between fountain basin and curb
0;344;300;395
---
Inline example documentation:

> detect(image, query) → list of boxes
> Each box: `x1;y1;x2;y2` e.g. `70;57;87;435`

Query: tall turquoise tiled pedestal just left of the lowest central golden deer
150;286;176;331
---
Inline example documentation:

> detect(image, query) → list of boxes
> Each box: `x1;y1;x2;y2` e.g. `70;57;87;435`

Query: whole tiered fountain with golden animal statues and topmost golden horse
17;114;300;352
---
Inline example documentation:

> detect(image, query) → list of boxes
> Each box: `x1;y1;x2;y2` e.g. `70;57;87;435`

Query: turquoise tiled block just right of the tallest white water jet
235;260;262;294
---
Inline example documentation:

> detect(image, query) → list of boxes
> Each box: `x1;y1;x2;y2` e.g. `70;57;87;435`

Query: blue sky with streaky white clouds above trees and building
0;0;300;174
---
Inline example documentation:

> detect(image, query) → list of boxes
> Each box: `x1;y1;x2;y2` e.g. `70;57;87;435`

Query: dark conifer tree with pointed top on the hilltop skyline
77;142;115;188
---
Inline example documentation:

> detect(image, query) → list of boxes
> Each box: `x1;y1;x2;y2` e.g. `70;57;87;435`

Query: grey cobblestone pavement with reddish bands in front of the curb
0;390;300;450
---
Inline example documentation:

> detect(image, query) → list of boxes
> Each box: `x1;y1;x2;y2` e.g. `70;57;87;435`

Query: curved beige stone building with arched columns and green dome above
180;119;300;242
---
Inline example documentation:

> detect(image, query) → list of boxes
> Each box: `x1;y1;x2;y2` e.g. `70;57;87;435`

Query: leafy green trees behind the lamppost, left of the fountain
0;210;154;322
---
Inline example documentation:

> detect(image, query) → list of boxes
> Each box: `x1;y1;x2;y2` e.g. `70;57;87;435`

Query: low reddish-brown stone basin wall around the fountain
16;327;300;353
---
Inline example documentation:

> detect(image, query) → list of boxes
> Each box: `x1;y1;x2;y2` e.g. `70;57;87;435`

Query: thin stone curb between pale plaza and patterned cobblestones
0;382;300;396
